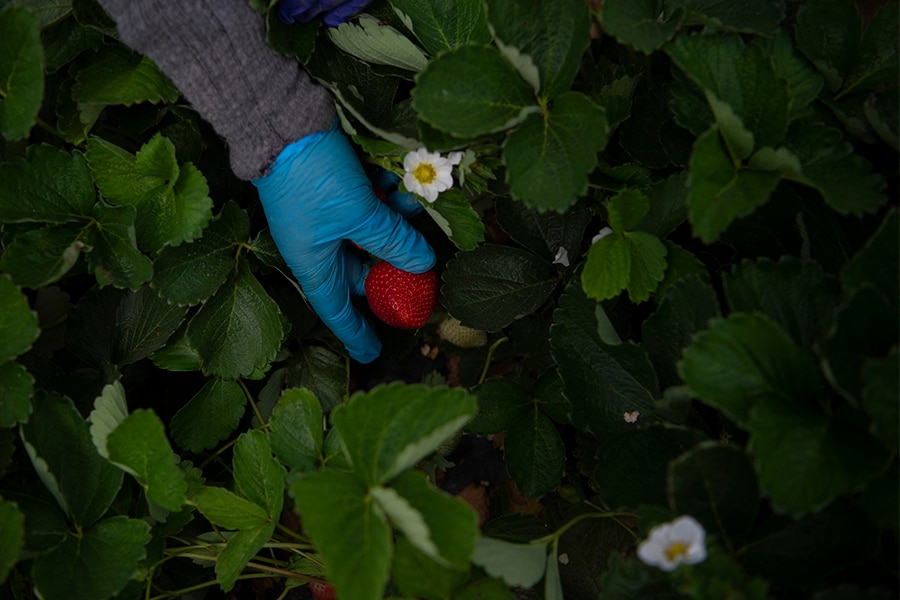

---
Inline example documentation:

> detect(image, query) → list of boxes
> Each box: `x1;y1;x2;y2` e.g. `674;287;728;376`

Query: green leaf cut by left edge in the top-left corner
0;7;44;142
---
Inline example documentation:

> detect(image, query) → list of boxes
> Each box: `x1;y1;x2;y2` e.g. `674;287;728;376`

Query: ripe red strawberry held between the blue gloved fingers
366;260;437;329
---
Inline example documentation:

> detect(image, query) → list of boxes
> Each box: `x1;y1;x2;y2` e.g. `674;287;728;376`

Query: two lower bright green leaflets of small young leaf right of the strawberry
581;231;667;303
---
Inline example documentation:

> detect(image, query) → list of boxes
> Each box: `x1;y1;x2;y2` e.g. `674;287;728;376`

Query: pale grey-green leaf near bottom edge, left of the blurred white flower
472;536;547;588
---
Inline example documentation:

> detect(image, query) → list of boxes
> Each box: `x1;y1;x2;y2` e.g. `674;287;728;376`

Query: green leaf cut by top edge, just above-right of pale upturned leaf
391;0;491;56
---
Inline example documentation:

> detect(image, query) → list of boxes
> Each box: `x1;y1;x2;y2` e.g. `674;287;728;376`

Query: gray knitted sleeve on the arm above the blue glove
100;0;335;179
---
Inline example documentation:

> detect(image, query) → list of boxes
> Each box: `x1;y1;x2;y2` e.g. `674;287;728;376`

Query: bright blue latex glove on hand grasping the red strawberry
253;122;435;362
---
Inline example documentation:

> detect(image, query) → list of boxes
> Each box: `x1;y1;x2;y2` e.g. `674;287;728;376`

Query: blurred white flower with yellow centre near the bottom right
637;515;706;571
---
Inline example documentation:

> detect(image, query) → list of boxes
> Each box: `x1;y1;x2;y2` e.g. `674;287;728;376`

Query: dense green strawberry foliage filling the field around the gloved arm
0;0;900;600
